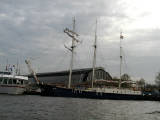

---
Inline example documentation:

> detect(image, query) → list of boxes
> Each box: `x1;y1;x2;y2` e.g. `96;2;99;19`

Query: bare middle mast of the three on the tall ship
91;20;97;88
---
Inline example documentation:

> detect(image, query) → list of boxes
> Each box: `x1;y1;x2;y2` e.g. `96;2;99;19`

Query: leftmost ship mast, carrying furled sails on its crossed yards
64;18;79;88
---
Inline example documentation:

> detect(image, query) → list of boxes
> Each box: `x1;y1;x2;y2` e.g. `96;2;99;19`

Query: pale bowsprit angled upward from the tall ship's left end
25;60;40;85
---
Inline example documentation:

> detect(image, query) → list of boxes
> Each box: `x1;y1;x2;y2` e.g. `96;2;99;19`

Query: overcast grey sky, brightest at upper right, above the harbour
0;0;160;83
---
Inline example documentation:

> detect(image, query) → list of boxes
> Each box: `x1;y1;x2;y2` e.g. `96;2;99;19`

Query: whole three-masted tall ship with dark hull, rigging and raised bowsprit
26;19;160;101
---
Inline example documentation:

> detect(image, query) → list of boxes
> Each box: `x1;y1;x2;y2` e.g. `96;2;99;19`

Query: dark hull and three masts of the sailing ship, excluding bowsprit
41;19;160;101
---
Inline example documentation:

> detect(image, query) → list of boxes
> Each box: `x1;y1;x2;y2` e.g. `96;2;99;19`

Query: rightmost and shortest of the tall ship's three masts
119;32;123;89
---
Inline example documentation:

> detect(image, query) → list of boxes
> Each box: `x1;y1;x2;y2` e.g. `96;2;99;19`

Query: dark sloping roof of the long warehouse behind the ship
29;67;109;77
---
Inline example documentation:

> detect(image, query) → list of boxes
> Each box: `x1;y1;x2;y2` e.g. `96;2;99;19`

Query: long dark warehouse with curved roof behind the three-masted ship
29;67;112;86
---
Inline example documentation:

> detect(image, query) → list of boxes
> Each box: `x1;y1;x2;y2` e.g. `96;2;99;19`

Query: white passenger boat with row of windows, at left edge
0;72;28;94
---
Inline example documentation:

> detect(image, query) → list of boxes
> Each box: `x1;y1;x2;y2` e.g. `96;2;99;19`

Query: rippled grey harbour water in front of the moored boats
0;95;160;120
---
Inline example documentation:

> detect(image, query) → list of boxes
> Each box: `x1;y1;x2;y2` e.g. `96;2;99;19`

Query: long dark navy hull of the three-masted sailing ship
41;86;160;101
